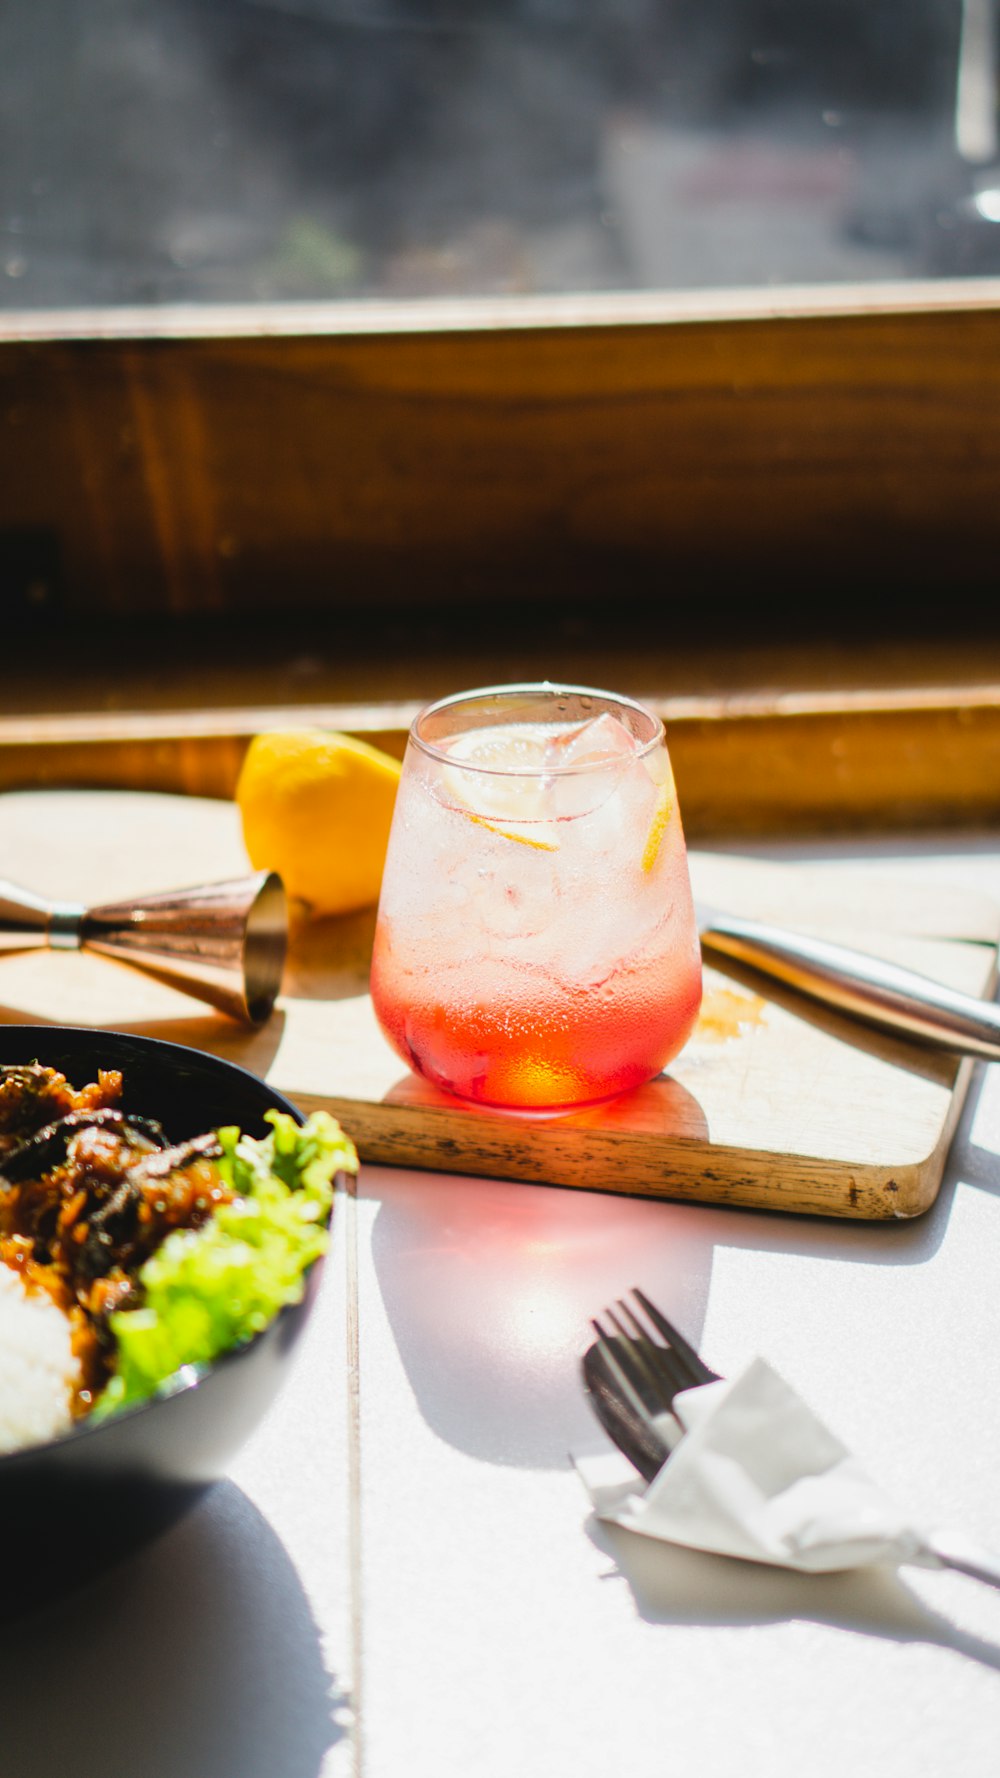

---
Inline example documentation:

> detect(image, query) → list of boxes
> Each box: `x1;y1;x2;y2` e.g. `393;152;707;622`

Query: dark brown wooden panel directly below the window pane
0;295;1000;619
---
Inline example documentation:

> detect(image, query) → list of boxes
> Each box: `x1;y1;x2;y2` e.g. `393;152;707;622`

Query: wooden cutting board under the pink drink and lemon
0;789;1000;1218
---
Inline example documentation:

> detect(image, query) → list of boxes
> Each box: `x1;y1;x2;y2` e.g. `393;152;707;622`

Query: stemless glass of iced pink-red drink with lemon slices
372;683;701;1111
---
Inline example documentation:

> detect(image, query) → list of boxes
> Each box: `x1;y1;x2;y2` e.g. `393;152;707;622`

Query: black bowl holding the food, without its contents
0;1026;334;1598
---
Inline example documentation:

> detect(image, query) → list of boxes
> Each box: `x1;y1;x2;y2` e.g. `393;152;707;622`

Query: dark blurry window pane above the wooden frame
0;0;1000;308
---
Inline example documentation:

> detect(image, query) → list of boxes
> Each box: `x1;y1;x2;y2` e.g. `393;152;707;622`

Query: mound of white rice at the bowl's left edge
0;1261;77;1453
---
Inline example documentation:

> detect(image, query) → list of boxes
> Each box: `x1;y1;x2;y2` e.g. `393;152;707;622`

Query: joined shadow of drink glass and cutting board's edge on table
359;1038;1000;1469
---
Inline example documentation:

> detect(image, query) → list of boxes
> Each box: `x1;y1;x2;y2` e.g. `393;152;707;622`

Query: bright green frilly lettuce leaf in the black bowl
91;1111;358;1419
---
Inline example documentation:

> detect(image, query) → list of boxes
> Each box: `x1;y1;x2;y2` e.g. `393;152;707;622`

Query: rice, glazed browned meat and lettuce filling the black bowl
0;1061;358;1453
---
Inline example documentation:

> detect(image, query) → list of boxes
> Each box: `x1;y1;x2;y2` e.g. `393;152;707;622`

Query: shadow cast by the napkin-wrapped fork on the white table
587;1518;1000;1671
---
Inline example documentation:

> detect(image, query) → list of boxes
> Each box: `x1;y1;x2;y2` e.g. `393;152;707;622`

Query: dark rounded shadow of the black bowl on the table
0;1483;345;1778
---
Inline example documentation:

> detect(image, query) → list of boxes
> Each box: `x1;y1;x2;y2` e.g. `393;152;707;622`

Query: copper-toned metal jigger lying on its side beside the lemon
0;871;288;1024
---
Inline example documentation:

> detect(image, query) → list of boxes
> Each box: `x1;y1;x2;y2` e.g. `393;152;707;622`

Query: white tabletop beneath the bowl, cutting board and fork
0;841;1000;1778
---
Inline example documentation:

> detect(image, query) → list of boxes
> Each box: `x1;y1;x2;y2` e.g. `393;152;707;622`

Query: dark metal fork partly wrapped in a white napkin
582;1287;1000;1588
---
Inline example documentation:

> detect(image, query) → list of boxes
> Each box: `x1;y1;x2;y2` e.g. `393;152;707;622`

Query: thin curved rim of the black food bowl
0;1024;325;1476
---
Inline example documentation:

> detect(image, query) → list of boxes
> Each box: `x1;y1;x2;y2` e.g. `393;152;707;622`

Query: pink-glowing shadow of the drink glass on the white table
361;1172;712;1469
